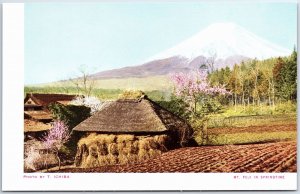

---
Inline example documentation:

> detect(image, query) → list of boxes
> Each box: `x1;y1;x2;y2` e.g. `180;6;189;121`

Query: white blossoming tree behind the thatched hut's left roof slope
70;96;102;114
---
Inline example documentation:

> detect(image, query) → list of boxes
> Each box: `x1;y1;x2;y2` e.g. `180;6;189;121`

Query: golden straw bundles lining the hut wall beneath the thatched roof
75;133;172;168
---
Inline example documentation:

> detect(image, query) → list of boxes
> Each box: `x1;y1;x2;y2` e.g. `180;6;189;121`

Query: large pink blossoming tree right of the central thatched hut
171;70;230;114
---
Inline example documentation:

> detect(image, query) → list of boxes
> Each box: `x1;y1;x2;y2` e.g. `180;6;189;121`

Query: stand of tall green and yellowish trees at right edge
209;49;297;106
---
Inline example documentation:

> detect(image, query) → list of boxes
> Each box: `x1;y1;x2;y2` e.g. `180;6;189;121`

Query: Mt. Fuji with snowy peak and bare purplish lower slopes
92;23;291;79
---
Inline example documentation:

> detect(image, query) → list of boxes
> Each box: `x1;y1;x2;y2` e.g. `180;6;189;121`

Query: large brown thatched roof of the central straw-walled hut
73;96;189;133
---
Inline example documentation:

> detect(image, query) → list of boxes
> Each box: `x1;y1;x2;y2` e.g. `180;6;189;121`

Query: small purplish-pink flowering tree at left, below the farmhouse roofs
43;120;70;169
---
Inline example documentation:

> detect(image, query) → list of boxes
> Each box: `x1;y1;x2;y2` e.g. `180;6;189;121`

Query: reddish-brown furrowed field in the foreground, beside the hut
55;141;297;173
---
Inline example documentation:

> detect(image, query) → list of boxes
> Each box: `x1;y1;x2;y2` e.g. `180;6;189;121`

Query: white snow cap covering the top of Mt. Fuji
148;23;291;61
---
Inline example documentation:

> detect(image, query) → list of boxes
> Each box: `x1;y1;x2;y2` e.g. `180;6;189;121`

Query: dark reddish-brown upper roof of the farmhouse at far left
24;93;76;106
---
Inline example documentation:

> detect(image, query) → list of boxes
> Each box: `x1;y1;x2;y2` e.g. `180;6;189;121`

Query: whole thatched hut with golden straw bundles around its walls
73;96;192;167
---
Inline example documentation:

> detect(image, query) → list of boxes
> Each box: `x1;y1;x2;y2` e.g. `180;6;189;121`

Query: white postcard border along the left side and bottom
2;3;297;191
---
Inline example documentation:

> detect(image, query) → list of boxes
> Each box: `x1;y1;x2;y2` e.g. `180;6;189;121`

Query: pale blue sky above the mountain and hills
24;2;297;85
